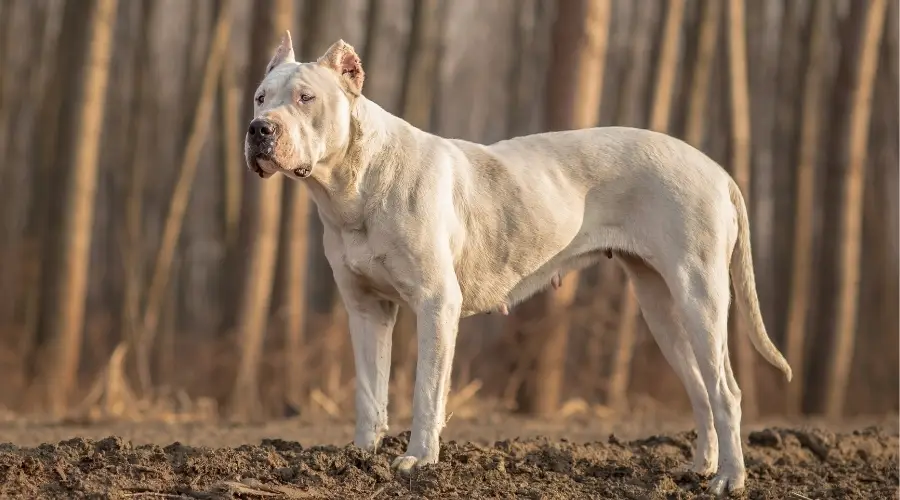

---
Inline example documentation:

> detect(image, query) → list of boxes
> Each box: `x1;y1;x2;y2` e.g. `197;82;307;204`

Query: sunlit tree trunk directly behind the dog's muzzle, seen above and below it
230;0;294;421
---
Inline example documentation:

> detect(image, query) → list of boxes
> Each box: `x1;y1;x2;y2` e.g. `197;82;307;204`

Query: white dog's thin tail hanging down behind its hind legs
728;178;792;382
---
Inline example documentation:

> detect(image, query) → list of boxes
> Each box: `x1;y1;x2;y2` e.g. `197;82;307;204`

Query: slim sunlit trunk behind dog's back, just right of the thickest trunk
608;0;684;408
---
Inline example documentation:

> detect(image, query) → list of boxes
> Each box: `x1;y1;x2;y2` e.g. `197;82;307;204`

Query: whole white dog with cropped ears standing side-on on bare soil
245;33;791;494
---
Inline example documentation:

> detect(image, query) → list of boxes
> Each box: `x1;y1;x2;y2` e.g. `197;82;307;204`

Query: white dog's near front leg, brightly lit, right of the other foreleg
393;281;462;473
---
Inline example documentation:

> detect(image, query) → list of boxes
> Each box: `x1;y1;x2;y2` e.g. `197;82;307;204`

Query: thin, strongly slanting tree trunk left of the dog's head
137;0;232;394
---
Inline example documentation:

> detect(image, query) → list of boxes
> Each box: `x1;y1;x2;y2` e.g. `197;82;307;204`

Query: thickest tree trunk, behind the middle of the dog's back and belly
519;0;610;416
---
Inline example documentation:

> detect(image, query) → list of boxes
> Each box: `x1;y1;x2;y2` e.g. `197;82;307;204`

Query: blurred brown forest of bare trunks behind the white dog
0;0;900;421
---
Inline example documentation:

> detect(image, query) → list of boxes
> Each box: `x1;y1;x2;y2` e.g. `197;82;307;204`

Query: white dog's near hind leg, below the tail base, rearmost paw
666;258;746;495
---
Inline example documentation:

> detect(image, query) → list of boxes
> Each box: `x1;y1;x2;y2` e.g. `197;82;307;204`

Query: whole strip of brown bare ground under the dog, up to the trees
0;412;898;500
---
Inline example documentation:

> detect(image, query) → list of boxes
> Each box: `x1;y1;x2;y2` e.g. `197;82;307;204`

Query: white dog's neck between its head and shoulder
306;96;411;230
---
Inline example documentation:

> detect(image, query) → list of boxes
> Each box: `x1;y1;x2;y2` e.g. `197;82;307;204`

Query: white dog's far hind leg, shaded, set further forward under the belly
618;255;719;476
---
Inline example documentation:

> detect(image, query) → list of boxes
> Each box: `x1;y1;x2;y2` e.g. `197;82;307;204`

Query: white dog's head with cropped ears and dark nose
244;32;365;179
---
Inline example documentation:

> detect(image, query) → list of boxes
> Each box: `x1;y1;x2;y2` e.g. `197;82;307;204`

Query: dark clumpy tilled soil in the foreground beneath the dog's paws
0;428;898;500
